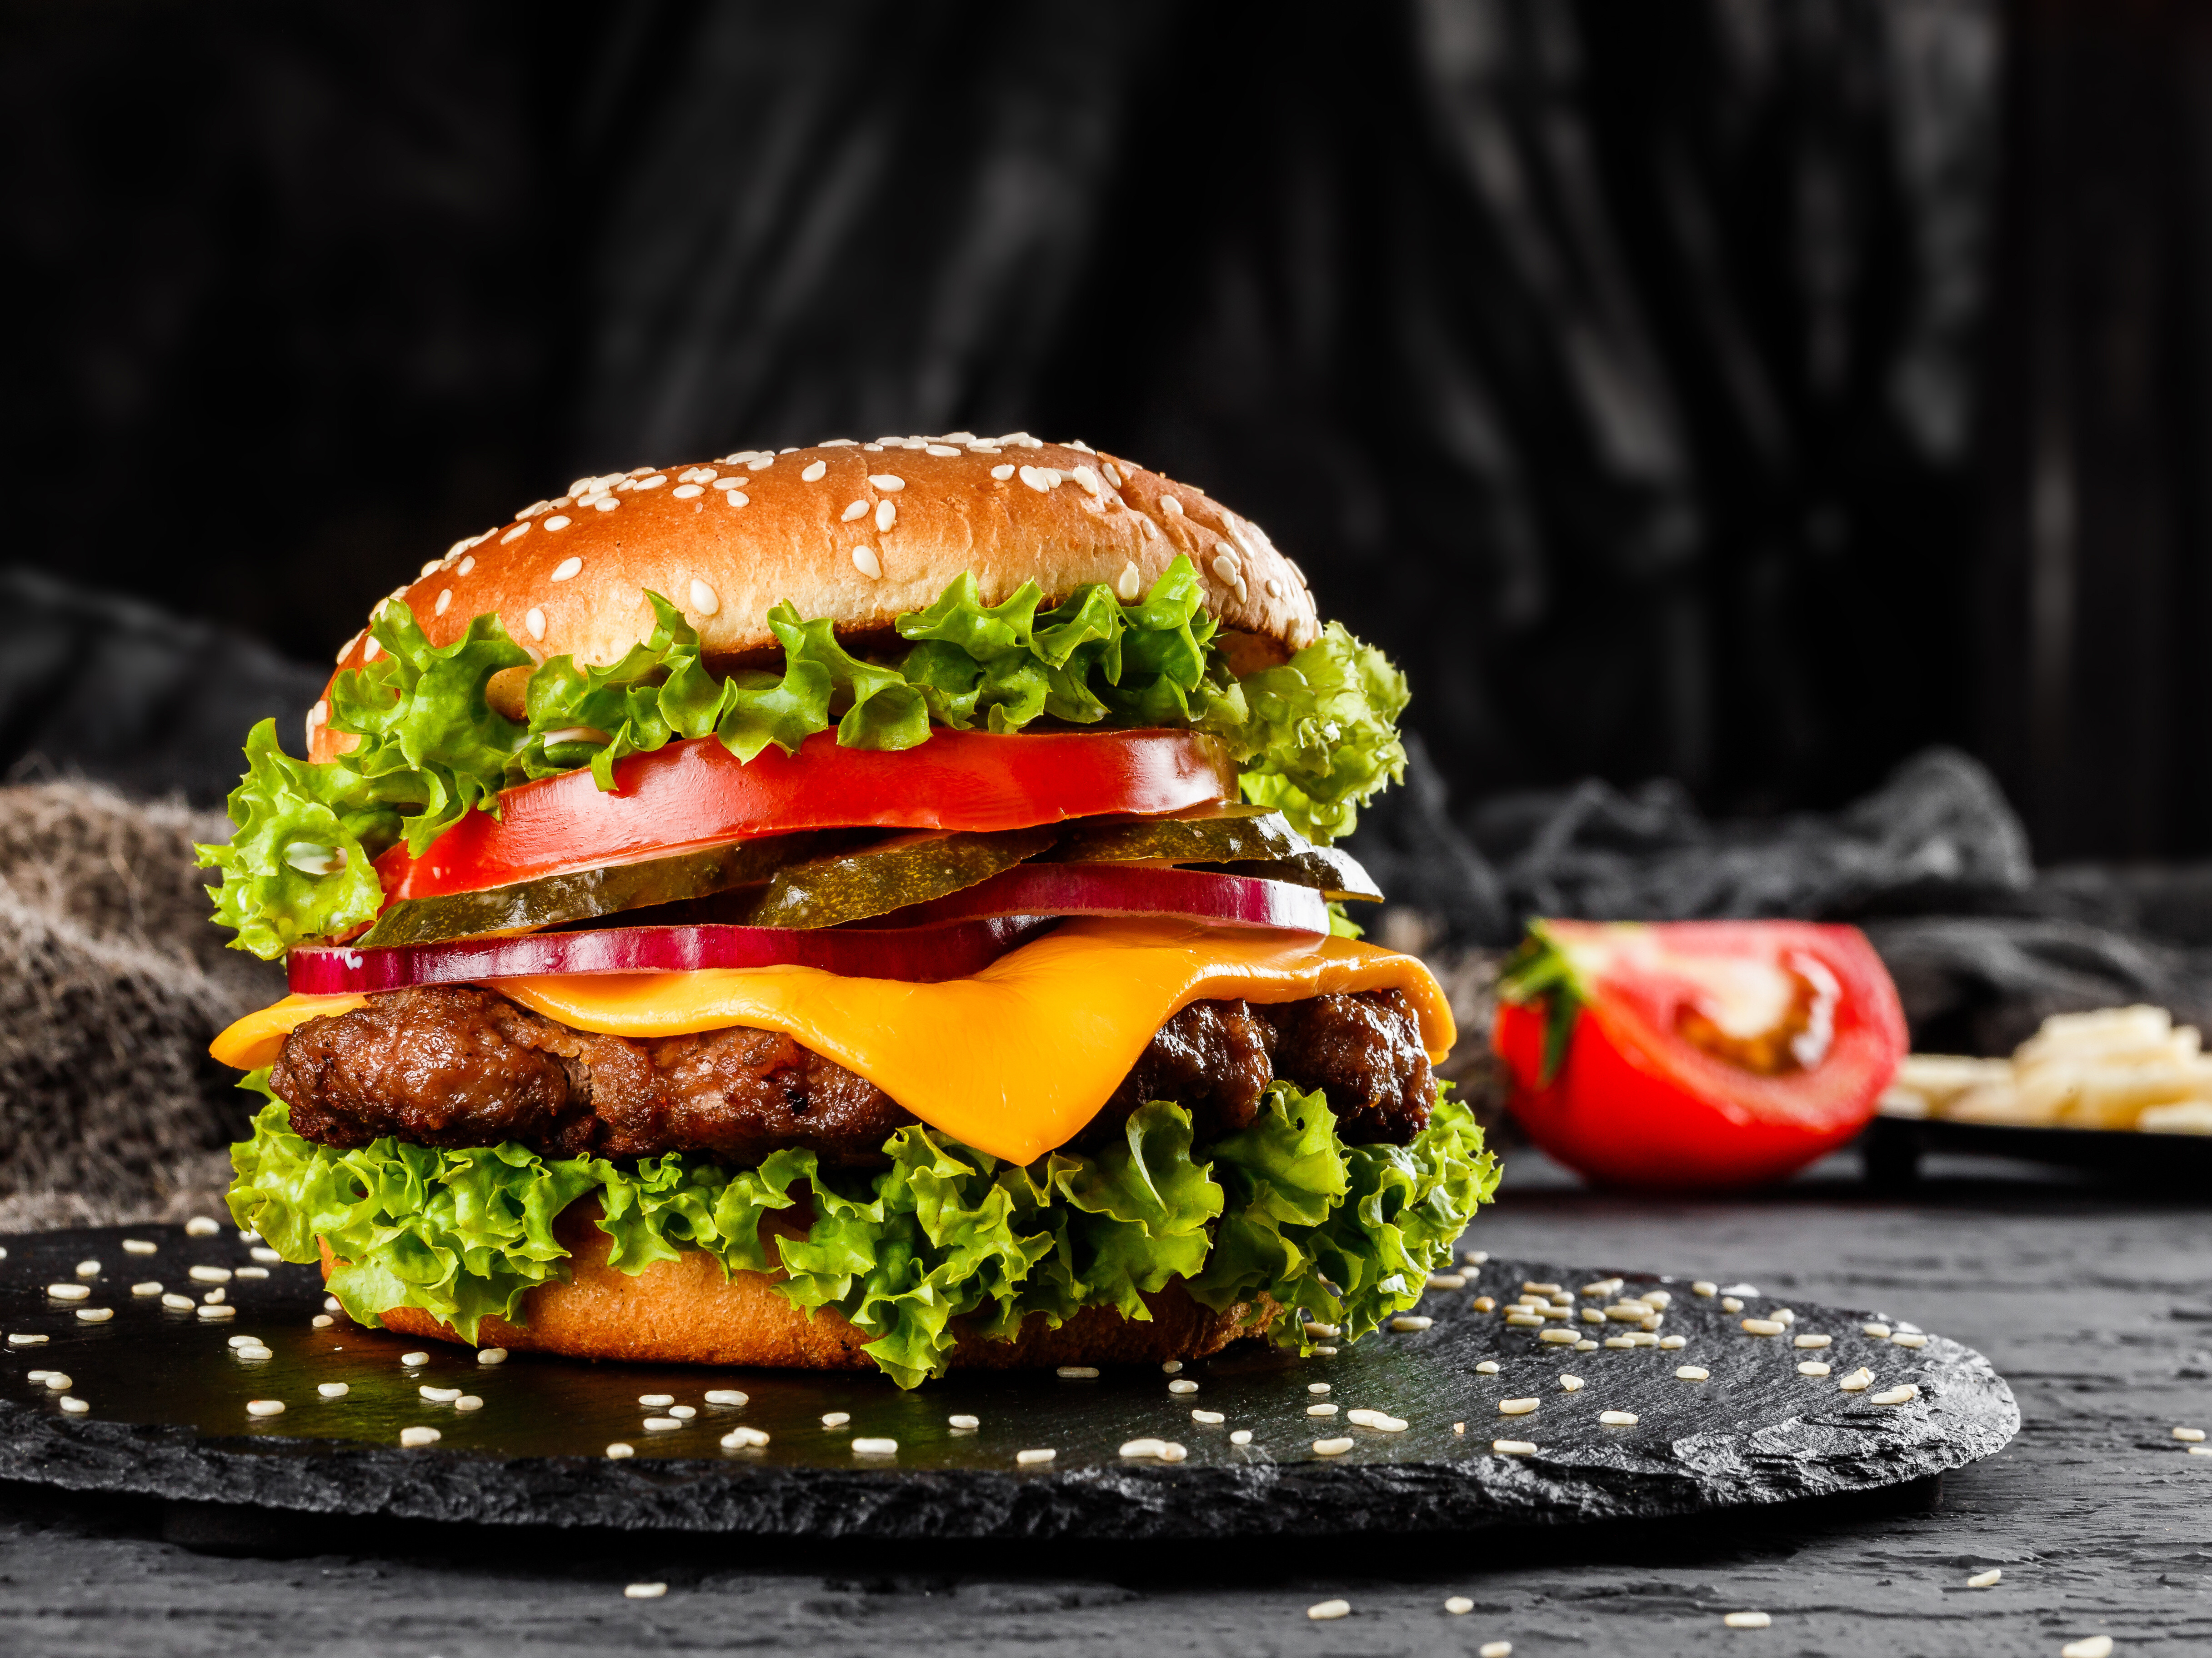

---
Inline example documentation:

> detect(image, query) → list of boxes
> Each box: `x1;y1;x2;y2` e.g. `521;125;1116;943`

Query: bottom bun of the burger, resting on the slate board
323;1200;1283;1371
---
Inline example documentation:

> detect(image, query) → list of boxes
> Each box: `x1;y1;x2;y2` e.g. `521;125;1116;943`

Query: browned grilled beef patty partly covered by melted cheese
270;986;1436;1167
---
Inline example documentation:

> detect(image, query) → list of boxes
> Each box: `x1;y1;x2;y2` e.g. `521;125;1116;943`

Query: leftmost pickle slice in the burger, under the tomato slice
358;831;836;946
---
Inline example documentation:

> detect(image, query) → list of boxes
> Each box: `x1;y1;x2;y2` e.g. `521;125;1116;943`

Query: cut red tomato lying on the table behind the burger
1491;922;1907;1187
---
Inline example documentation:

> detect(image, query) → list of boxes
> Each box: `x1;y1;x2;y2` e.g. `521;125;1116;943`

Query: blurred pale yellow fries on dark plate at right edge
1880;1008;2212;1134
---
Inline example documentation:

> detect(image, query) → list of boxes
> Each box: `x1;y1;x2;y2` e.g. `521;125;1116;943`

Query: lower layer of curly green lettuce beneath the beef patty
230;1072;1497;1388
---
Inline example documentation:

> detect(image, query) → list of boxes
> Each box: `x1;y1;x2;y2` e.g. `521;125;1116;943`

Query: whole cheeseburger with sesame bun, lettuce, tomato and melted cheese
201;431;1495;1386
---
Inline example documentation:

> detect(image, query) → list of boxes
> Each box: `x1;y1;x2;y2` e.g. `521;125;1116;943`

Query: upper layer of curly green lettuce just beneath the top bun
199;557;1405;957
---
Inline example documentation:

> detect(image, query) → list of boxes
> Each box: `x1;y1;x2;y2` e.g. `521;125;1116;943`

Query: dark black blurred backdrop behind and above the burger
0;0;2212;862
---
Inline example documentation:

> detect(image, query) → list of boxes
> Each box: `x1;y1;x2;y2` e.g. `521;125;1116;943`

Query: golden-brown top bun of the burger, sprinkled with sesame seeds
319;431;1321;716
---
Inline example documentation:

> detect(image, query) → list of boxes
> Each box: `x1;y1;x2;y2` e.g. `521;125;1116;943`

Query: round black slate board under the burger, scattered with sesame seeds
0;1227;2020;1538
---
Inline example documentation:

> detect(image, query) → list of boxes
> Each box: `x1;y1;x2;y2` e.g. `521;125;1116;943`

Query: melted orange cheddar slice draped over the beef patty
210;919;1456;1163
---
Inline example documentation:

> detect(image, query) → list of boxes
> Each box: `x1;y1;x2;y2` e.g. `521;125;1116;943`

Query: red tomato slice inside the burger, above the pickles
376;732;1236;900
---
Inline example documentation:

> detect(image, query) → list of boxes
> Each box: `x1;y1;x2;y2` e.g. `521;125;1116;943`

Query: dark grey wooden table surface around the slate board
0;1152;2212;1658
